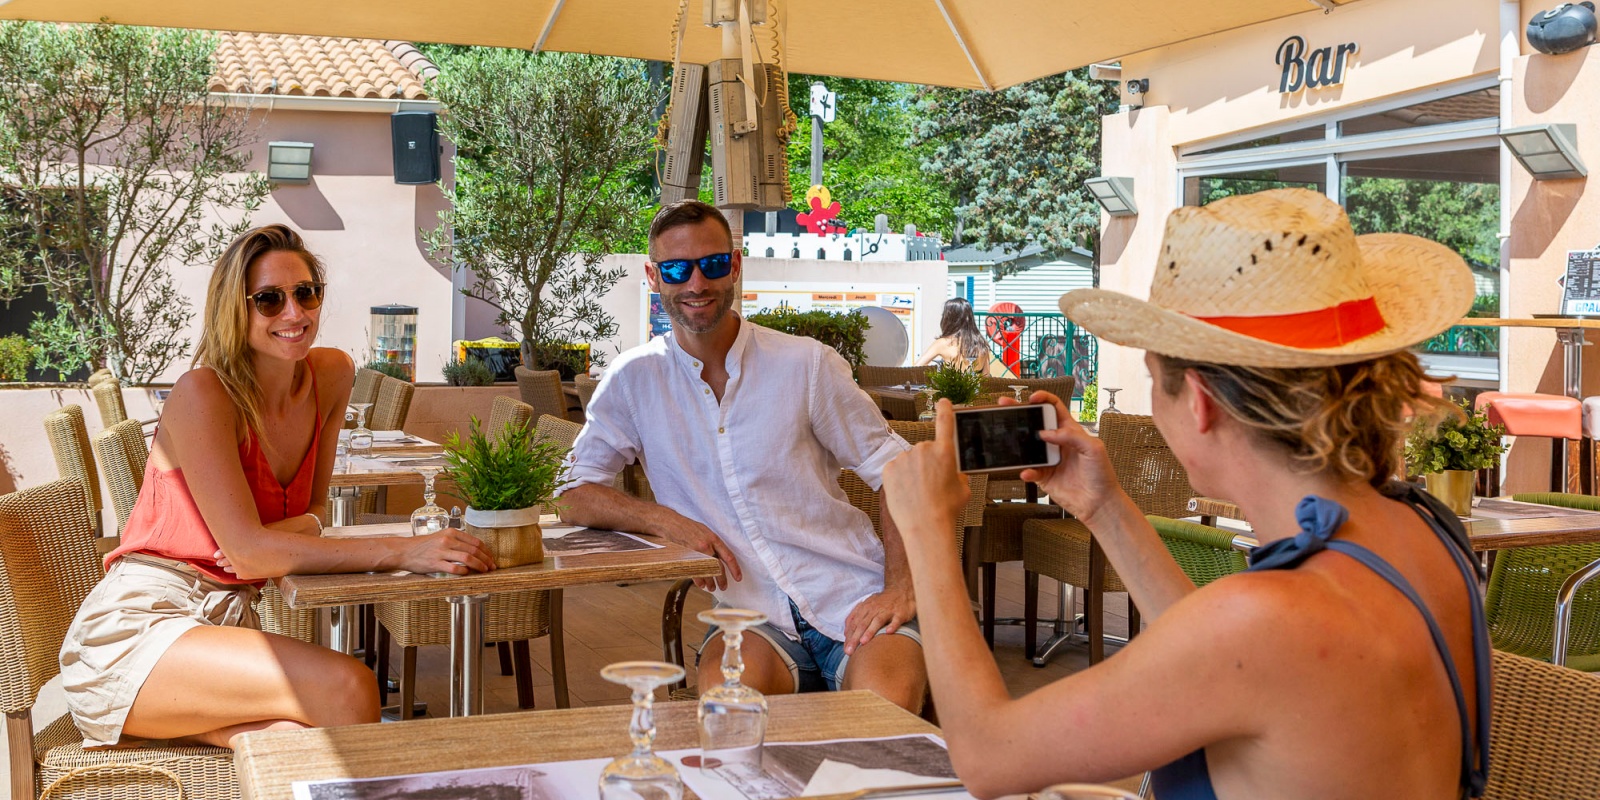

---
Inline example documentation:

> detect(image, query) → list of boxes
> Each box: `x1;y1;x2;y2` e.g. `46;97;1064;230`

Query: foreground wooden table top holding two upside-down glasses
234;691;939;800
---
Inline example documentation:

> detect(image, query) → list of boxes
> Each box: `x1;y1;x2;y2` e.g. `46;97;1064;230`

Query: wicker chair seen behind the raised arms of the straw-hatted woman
1022;413;1194;664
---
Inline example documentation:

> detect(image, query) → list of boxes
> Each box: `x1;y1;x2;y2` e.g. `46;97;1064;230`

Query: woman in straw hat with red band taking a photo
885;189;1490;800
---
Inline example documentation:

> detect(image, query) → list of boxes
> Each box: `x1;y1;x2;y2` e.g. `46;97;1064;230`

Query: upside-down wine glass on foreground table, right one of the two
698;608;766;774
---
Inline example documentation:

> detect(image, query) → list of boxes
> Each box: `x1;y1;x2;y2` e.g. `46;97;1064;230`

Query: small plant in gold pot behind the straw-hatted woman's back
1405;402;1506;517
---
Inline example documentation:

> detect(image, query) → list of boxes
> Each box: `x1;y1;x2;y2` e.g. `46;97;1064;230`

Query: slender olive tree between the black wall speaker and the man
424;48;656;366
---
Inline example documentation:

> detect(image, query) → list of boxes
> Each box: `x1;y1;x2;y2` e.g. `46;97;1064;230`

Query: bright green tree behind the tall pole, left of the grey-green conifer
789;75;955;230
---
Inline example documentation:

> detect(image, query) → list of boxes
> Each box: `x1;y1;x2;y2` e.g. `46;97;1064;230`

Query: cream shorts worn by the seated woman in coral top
61;554;261;747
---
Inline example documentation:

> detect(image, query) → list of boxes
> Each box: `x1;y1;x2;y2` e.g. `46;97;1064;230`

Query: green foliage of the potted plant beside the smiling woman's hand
445;416;568;510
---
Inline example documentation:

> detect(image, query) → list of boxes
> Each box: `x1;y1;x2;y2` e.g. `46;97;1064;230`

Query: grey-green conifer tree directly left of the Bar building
910;69;1117;278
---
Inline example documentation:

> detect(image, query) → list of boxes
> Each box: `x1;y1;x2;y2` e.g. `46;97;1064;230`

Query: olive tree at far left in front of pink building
0;22;267;382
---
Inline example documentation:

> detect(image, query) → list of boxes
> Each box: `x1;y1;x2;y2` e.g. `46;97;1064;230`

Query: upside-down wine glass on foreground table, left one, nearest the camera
600;661;683;800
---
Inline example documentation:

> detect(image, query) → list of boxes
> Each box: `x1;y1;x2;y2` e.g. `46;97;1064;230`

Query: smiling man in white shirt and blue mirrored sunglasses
562;200;926;710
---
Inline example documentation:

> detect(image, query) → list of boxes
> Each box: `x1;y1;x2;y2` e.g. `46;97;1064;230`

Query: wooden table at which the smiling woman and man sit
272;528;722;717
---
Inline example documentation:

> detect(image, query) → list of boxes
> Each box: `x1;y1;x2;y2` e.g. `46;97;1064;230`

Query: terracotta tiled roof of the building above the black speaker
211;32;438;99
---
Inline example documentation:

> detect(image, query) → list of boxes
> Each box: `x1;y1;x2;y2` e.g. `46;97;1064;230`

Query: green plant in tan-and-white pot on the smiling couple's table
445;416;568;568
